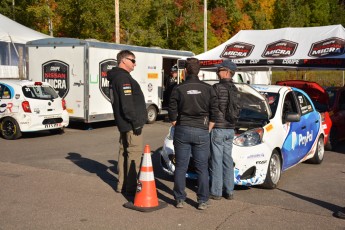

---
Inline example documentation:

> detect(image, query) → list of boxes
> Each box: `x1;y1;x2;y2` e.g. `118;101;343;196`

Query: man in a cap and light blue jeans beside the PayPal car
210;60;237;200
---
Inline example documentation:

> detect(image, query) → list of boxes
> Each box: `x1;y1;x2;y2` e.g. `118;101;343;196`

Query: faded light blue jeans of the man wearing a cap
210;129;235;196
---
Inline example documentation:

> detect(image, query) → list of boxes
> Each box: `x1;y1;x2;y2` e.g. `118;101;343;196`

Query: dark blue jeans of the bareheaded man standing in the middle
174;125;210;203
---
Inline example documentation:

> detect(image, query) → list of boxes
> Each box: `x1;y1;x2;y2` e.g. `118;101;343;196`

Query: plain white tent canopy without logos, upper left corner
0;14;50;44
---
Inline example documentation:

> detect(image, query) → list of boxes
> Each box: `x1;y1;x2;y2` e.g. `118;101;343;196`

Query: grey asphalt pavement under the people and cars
0;120;345;230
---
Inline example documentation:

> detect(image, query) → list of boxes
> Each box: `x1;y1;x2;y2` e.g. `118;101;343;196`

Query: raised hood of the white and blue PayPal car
235;84;272;119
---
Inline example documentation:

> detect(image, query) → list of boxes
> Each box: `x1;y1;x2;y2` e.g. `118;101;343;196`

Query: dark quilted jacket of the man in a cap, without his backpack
213;78;237;129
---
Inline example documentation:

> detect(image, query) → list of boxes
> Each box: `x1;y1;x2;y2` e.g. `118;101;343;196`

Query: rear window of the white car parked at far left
22;85;59;100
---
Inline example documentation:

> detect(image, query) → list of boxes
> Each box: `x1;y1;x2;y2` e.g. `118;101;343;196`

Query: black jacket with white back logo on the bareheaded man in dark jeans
169;76;218;129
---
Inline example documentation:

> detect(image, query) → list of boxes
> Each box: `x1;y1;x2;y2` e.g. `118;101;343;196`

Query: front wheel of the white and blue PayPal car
263;150;281;189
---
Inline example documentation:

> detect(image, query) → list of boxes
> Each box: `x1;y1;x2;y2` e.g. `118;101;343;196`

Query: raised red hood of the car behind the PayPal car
276;80;329;107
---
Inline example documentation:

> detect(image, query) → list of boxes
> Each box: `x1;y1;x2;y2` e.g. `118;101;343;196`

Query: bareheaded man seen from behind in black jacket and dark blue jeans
168;58;218;210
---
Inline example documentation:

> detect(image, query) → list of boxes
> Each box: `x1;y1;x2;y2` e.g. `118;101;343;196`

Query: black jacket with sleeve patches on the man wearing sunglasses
107;67;147;132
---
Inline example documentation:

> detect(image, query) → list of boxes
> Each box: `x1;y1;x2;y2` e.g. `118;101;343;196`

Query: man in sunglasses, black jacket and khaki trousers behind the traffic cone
107;50;147;196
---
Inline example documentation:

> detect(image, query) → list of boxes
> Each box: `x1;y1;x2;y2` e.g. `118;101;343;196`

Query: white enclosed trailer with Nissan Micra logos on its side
26;38;194;123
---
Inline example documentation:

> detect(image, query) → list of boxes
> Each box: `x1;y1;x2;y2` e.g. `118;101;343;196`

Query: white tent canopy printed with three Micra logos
195;25;345;70
